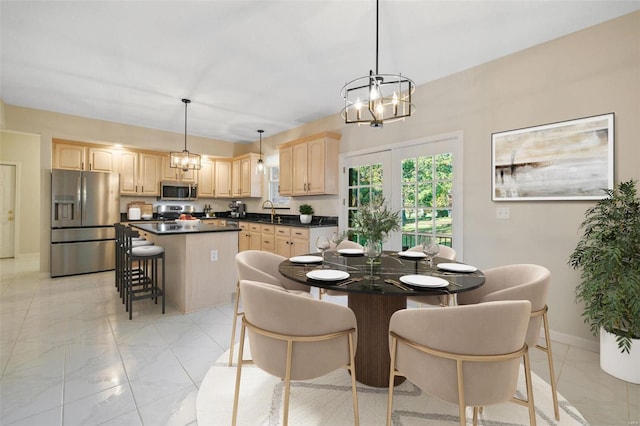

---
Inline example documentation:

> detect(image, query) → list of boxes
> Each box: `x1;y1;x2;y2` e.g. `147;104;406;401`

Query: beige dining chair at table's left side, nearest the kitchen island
229;250;311;365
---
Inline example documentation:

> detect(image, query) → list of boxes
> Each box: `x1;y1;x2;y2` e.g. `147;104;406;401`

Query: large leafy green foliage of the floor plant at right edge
569;180;640;352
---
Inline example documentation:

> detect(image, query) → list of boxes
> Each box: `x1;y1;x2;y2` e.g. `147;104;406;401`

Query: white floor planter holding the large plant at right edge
600;328;640;384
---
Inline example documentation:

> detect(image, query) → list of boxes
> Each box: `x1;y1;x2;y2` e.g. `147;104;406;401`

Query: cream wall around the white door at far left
0;131;41;257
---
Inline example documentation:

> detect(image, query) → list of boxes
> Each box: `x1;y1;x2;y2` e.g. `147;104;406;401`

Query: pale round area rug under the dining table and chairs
196;350;587;426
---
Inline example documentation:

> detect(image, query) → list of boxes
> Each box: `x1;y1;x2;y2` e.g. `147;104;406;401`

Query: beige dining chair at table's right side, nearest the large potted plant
458;263;560;420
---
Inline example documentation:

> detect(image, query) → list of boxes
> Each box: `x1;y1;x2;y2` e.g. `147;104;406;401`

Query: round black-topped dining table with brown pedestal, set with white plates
279;250;485;387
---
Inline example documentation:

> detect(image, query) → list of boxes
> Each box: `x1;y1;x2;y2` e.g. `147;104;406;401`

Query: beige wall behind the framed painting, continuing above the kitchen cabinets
5;13;640;347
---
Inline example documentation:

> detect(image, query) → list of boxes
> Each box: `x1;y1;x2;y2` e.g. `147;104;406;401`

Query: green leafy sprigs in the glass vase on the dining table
352;197;400;242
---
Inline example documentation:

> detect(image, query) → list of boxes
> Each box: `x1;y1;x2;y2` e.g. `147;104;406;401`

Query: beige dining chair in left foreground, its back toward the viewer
232;280;359;426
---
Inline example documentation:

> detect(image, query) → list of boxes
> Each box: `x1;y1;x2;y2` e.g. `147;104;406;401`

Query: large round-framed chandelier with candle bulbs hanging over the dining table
341;0;415;127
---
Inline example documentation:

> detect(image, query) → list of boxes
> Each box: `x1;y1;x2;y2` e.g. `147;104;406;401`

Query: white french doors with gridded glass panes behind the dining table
340;132;462;258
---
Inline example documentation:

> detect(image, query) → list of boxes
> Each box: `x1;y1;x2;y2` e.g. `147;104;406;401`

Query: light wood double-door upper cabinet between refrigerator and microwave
118;151;161;196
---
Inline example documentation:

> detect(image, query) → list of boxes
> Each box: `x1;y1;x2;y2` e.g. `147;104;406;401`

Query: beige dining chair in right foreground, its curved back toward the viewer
387;300;536;426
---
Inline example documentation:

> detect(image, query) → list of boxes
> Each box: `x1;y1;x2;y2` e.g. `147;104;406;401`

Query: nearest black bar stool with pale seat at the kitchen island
123;227;165;319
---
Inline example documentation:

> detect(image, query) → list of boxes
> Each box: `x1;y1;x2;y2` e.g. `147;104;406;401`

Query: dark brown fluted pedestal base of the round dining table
349;293;407;388
